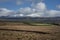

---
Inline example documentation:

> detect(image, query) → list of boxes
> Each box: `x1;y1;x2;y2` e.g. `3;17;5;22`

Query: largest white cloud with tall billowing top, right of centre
16;2;46;17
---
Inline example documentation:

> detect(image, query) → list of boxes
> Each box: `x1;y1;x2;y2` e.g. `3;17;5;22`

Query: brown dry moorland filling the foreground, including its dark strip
0;22;60;40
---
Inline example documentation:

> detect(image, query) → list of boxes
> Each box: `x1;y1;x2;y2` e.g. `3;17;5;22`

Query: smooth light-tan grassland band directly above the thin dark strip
0;25;57;32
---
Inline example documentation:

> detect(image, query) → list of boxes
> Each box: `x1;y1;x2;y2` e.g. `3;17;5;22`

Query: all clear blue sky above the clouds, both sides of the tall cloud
0;0;60;10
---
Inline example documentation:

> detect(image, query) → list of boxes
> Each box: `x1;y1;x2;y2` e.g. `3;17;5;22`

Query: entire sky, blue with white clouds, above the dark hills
0;0;60;17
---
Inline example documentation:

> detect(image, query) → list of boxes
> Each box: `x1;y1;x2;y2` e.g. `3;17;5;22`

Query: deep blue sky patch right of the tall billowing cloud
45;0;60;9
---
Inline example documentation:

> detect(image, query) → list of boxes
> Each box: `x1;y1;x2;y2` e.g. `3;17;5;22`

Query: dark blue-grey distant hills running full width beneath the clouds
0;17;60;23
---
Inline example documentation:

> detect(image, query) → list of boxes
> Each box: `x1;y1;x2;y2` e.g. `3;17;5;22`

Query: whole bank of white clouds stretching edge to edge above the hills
0;2;60;17
